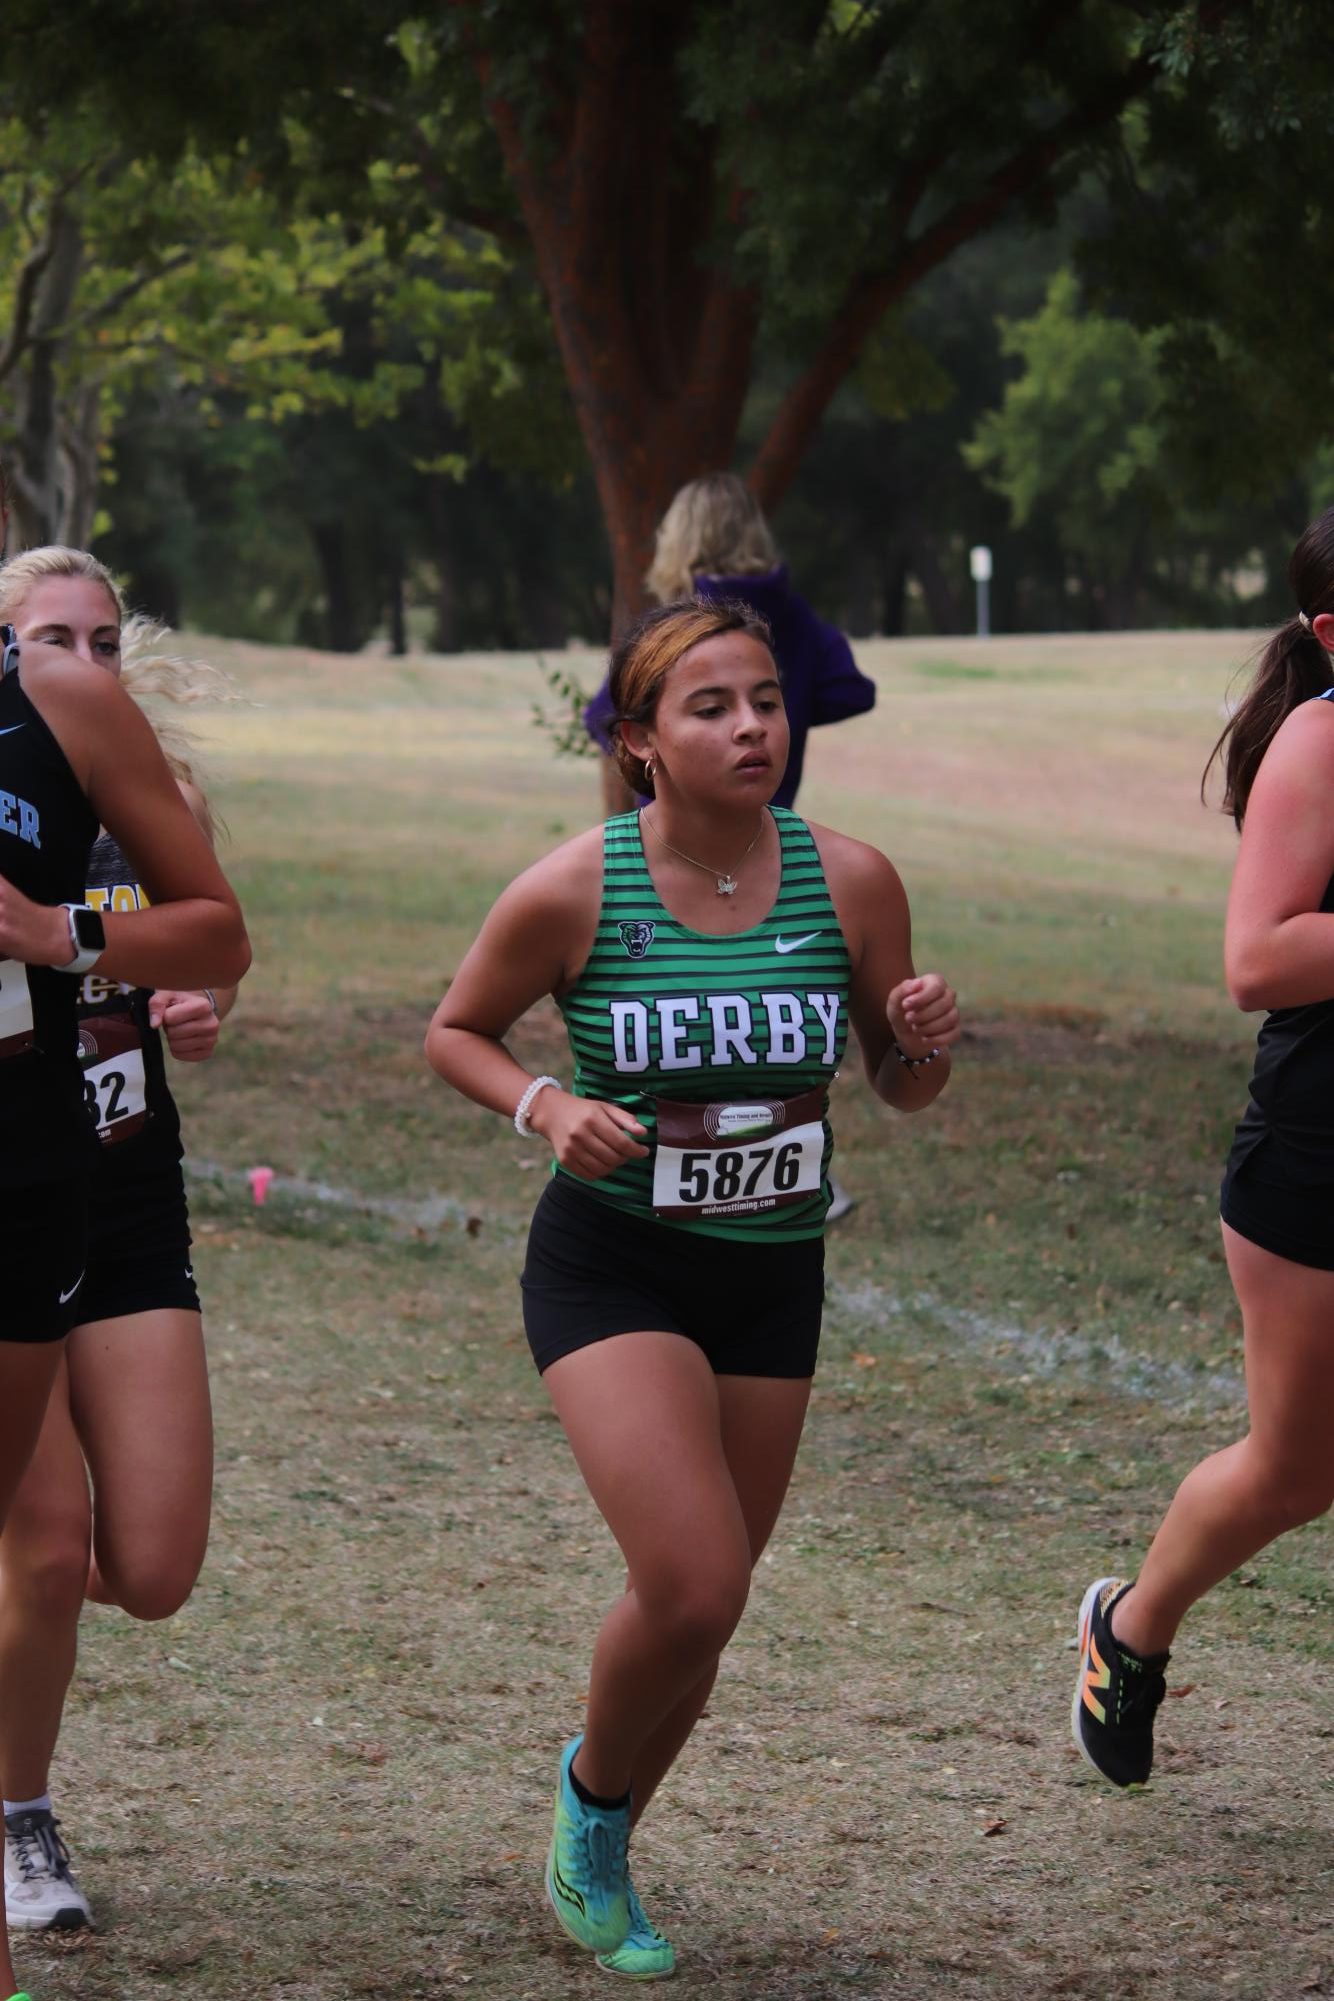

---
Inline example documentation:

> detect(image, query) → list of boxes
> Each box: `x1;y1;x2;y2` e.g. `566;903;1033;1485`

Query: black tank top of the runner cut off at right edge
1236;688;1334;1176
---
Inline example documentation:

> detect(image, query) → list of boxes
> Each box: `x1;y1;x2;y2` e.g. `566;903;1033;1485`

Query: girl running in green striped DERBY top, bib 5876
426;600;958;1979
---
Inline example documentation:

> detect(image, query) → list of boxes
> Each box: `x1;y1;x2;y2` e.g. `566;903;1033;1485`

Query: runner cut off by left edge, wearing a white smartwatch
0;524;250;1993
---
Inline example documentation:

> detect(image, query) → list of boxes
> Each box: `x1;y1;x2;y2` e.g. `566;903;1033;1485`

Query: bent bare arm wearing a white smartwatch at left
0;658;250;986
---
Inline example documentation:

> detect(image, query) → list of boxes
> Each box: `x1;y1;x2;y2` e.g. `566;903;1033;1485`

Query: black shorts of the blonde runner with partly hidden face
74;1149;200;1327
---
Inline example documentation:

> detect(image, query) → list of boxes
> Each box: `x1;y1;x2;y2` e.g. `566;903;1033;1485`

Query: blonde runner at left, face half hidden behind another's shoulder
0;548;236;1931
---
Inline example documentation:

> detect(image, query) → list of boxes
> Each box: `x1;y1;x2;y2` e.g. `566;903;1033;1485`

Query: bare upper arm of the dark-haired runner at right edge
1224;702;1334;1013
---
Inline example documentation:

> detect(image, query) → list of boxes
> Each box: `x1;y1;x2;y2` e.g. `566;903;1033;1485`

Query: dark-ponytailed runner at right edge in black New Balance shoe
1072;508;1334;1787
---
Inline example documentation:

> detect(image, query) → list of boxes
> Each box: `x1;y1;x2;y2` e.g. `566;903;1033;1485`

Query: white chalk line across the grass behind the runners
186;1161;1244;1405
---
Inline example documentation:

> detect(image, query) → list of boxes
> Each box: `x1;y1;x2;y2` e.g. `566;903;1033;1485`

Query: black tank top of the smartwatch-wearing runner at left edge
0;646;98;1189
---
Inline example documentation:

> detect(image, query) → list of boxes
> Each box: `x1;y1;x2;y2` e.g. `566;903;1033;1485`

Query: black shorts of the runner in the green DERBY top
520;1175;824;1381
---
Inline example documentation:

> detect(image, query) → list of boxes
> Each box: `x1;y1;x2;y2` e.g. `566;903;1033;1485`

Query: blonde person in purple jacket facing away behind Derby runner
584;472;876;812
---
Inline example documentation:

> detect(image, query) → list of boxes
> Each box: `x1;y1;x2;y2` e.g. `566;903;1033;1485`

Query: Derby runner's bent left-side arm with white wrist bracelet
426;828;648;1181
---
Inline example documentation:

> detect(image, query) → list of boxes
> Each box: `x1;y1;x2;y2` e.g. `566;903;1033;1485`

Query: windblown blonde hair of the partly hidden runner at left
0;542;240;826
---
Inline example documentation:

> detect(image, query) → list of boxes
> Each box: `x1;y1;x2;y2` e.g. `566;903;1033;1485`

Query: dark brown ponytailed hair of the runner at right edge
1200;506;1334;826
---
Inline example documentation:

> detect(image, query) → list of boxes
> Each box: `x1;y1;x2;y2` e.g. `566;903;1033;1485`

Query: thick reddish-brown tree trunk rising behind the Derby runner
480;0;758;630
